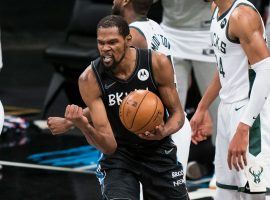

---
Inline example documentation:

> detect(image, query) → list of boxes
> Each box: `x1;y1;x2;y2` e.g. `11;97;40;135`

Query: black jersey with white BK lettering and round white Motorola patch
91;49;170;147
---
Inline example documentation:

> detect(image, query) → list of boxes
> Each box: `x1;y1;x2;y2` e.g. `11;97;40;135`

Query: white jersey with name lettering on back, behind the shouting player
129;19;172;56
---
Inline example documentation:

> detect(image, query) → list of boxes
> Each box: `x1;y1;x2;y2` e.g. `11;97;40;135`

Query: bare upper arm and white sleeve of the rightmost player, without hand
229;6;270;126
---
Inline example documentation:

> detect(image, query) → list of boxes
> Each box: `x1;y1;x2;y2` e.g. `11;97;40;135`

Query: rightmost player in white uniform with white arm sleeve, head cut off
191;0;270;200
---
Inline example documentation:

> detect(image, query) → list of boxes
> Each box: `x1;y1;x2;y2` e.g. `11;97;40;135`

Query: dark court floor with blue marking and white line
0;124;214;200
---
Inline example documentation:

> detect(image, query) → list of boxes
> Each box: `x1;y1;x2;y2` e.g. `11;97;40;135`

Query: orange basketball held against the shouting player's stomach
119;90;164;134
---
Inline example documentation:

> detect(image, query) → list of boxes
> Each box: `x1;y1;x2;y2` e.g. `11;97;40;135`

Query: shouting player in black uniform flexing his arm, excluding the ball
65;15;189;200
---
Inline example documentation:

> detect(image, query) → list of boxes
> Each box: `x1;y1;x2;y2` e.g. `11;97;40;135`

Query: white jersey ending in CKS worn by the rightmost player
210;0;265;103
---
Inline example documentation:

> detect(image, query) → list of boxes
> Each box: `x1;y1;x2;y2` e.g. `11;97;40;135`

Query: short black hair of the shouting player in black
97;15;130;37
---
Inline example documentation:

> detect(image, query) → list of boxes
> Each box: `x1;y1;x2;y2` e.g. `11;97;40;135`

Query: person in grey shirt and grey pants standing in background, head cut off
158;0;219;143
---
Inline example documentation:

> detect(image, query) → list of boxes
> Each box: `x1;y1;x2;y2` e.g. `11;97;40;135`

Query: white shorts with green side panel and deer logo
215;98;270;195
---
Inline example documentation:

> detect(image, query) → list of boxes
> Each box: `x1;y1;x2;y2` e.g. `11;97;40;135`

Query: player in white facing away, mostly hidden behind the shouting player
48;0;194;176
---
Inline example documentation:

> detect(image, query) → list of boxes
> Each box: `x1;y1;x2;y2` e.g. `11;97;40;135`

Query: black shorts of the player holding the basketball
97;140;189;200
